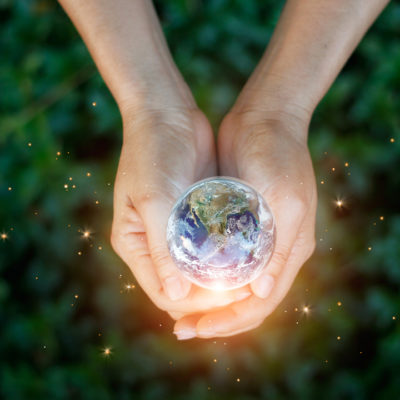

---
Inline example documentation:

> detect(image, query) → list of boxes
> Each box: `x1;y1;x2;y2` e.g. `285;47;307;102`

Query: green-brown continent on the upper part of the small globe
188;182;257;234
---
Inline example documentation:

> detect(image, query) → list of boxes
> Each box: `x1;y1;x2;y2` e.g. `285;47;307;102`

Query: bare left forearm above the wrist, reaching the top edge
59;0;194;112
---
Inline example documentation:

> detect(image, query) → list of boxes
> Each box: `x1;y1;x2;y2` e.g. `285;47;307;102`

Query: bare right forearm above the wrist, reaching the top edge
235;0;388;119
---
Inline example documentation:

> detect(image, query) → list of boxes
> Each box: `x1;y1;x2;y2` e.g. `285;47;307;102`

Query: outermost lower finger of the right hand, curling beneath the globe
196;227;312;338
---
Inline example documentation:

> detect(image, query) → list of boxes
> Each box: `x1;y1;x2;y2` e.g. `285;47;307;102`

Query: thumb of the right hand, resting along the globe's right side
250;195;306;299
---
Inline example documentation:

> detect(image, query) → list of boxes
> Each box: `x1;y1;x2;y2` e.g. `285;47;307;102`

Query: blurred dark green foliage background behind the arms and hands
0;0;400;400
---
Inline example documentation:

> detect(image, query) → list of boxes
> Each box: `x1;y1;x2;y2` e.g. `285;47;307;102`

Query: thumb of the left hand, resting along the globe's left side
135;192;191;300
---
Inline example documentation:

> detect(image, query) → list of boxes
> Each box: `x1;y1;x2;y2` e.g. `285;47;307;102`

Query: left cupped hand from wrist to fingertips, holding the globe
111;108;251;322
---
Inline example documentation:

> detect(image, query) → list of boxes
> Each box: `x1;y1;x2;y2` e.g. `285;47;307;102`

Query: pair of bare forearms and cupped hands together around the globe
60;0;388;340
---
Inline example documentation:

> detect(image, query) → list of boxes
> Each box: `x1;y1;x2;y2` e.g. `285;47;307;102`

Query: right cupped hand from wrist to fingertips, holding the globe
175;110;317;338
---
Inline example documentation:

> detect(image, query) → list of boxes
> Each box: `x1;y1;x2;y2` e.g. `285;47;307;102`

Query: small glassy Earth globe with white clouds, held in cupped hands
167;177;275;290
